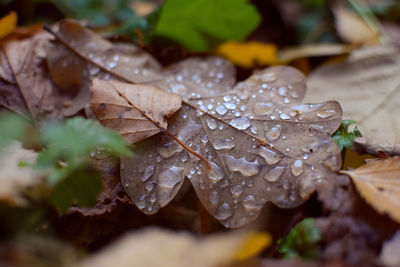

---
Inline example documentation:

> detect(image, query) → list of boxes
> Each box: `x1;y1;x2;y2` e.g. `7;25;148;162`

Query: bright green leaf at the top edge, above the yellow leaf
154;0;261;52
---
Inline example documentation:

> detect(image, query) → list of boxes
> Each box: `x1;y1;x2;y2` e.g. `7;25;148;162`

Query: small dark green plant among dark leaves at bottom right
278;218;322;260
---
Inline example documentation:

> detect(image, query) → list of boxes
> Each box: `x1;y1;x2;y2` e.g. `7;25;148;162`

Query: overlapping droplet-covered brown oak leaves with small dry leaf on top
0;21;342;227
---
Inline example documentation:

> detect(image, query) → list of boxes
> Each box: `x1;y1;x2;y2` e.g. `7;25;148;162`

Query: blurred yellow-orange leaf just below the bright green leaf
217;41;280;68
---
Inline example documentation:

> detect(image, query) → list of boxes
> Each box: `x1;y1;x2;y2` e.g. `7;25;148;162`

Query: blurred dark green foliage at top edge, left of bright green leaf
51;0;135;25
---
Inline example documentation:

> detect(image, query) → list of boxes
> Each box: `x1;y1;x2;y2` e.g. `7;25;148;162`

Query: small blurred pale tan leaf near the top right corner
333;6;380;44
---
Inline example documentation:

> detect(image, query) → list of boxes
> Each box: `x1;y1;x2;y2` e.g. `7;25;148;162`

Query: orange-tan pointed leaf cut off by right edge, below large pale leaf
341;156;400;225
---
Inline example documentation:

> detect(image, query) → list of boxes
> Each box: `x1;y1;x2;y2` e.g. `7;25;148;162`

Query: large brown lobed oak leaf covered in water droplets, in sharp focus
121;67;342;227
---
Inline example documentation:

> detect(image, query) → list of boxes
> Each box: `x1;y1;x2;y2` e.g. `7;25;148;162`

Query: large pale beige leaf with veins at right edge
305;46;400;154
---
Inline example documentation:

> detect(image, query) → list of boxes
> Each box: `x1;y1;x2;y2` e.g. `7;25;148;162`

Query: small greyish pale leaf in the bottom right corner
379;231;400;267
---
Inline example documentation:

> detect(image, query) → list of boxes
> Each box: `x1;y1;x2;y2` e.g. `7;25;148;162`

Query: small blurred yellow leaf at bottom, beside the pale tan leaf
236;232;272;261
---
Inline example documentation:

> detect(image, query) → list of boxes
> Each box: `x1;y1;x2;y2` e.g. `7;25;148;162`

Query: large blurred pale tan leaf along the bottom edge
77;228;252;267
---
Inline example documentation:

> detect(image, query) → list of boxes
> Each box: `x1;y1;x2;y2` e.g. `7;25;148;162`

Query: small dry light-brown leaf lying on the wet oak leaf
91;79;181;143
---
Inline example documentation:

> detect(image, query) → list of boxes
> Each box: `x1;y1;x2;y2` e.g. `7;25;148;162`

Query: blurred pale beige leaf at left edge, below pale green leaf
0;142;46;207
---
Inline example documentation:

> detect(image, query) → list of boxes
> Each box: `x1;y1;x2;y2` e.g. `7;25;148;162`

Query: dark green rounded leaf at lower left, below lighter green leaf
50;168;102;213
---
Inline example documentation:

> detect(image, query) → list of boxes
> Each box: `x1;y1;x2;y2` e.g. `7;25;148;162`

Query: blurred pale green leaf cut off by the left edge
0;113;30;149
